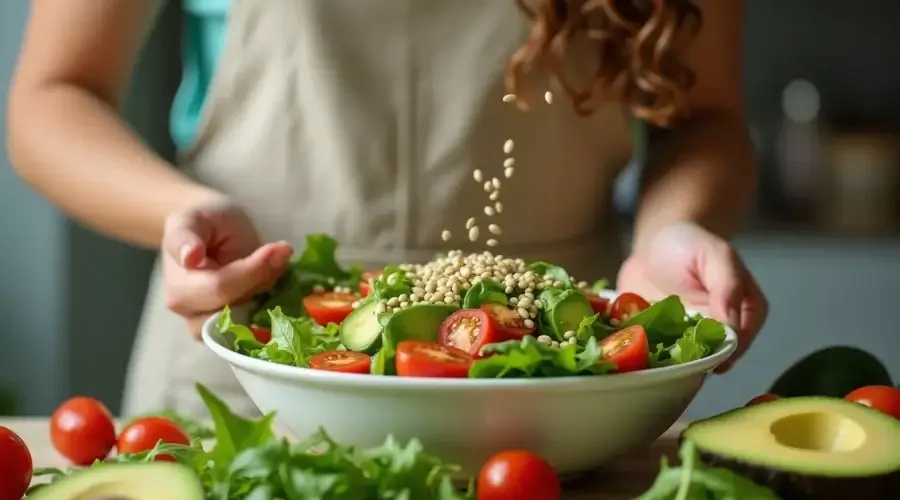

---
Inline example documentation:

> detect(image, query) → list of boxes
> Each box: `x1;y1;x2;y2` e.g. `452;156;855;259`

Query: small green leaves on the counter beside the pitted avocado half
637;441;779;500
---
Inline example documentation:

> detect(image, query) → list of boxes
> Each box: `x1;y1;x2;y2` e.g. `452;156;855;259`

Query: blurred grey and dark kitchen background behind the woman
0;0;900;417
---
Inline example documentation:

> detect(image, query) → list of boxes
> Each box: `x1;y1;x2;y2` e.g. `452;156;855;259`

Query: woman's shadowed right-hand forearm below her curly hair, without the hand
634;116;757;254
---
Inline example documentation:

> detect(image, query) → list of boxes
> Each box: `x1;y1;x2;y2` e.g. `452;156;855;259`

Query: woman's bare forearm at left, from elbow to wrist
7;83;217;247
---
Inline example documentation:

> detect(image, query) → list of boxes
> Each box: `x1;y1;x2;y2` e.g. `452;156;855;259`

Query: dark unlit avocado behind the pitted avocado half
769;346;894;398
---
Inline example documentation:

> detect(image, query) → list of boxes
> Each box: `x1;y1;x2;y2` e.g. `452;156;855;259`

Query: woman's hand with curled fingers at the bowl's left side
162;199;293;337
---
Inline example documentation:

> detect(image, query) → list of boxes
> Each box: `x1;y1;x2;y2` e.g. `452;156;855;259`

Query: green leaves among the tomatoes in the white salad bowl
227;235;725;378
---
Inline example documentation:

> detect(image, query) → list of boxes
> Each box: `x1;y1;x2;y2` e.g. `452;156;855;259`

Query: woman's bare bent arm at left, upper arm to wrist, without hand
7;0;223;246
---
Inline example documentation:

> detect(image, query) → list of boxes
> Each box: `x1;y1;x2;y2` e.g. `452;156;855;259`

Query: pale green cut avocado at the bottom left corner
28;462;205;500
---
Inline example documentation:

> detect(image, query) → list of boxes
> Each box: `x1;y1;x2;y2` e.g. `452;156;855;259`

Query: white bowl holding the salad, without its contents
203;296;737;475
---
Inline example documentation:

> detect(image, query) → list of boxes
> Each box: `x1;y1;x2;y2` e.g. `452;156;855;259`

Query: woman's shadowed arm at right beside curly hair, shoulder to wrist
635;0;757;249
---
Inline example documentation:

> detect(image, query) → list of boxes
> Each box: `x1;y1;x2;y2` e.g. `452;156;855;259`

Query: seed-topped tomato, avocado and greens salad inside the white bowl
217;235;725;378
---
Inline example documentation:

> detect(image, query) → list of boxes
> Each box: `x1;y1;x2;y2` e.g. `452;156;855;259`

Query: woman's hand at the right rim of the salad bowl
617;223;769;373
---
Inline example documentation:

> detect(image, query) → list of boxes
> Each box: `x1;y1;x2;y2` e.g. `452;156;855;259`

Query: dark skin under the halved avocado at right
679;437;900;500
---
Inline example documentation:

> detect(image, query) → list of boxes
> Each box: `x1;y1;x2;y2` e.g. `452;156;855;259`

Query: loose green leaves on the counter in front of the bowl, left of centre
29;385;473;500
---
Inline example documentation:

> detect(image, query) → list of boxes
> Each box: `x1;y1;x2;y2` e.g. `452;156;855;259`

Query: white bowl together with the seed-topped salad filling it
203;235;737;474
